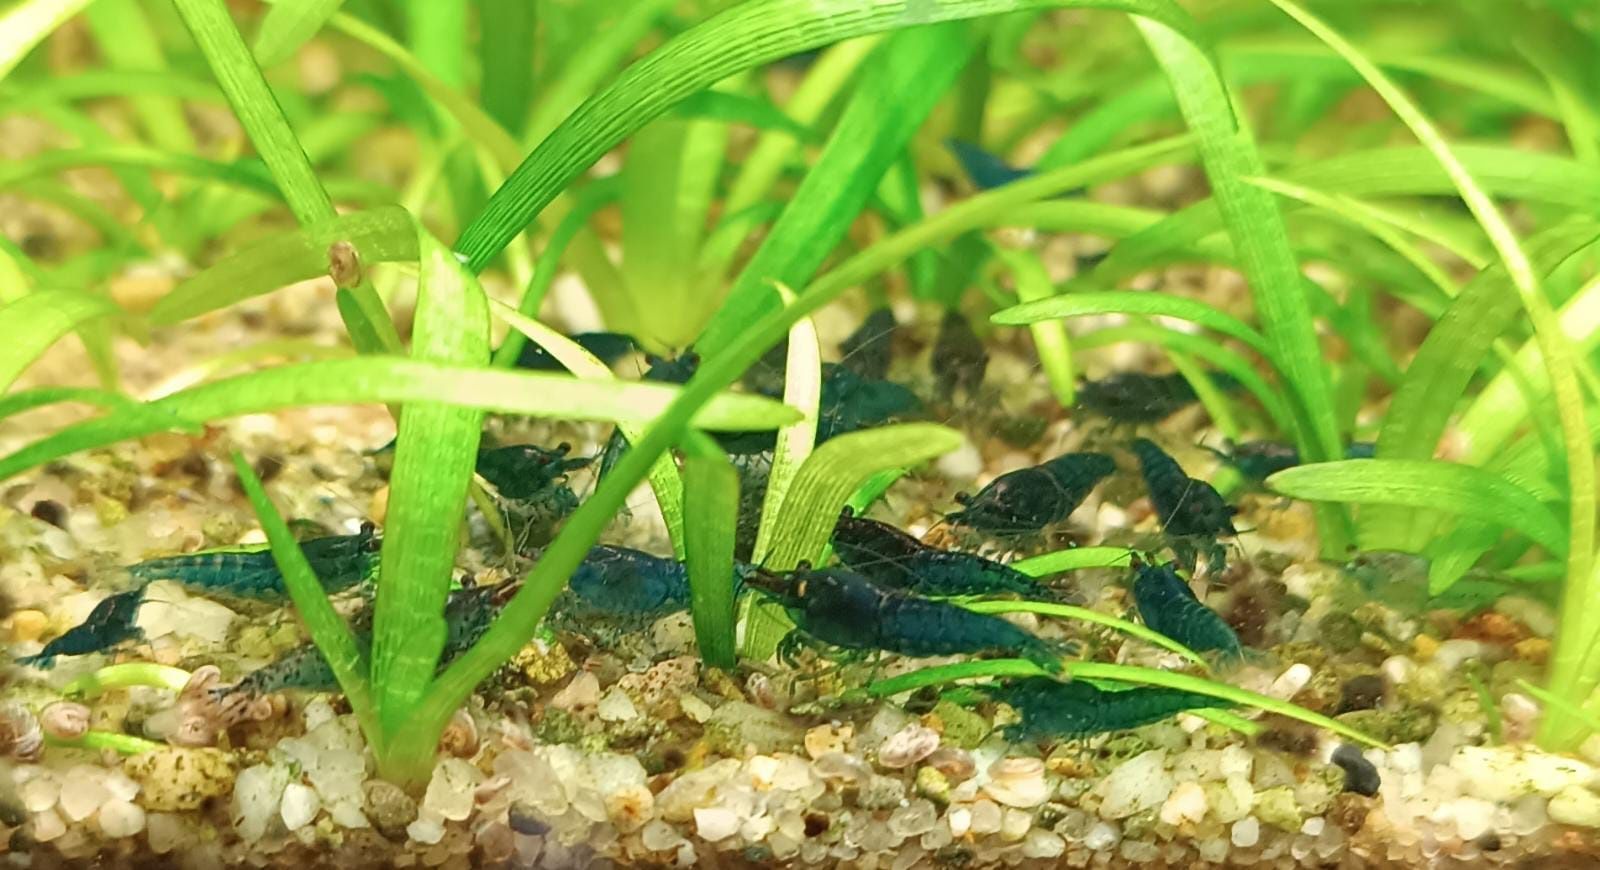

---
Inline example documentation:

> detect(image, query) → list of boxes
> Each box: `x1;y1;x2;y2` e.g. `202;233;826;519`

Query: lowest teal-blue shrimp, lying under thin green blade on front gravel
986;676;1232;740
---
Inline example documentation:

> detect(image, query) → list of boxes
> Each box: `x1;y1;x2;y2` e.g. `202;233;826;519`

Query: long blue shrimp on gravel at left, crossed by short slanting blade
128;523;382;600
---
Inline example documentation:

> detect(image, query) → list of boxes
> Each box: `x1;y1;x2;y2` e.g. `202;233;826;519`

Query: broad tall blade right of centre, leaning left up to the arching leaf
1136;21;1349;530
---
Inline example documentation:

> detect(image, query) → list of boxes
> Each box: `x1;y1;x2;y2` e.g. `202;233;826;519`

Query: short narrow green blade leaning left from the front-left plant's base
234;453;384;753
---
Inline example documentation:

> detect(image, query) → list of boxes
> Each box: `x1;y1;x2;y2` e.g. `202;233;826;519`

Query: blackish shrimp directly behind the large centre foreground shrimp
834;507;1061;601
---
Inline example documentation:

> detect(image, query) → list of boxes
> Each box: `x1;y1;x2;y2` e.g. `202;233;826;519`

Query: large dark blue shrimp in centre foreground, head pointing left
750;568;1064;670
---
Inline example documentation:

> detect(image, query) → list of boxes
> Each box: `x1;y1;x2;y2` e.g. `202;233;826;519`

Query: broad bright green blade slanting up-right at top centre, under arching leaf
696;24;976;352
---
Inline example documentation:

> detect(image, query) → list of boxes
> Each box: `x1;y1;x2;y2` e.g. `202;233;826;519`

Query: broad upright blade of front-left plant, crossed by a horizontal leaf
371;232;490;754
